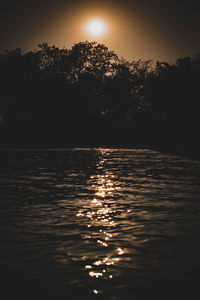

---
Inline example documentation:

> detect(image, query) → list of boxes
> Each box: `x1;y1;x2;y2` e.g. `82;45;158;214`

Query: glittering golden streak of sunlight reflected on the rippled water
76;150;125;294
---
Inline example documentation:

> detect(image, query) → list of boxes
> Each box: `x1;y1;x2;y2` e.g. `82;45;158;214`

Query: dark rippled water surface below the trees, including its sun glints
0;149;200;299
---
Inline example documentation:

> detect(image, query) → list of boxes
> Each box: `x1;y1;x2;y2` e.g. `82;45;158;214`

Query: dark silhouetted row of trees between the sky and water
0;41;200;155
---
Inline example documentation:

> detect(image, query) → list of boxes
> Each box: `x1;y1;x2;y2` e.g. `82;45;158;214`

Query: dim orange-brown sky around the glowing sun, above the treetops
0;0;200;61
